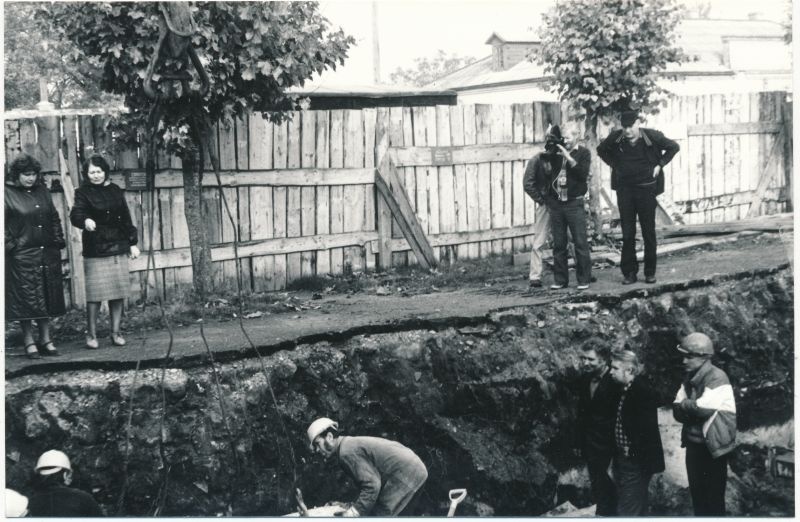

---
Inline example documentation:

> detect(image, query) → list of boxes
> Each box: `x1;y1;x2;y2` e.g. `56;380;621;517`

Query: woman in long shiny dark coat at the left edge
4;154;67;359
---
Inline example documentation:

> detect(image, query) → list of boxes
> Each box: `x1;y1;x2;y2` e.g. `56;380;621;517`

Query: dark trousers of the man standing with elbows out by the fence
617;184;658;277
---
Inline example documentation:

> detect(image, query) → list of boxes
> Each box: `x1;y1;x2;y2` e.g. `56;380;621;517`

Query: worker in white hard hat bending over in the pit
306;417;428;517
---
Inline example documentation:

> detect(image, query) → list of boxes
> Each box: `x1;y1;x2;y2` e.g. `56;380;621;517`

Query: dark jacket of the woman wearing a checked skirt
69;183;139;257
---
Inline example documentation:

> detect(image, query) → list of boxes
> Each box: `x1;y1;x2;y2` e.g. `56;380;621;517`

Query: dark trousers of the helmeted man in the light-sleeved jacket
686;442;728;517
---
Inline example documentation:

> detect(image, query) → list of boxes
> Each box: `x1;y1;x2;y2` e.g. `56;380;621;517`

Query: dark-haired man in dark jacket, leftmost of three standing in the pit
578;341;620;516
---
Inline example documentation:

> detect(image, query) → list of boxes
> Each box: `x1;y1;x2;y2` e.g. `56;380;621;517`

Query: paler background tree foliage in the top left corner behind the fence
3;2;122;110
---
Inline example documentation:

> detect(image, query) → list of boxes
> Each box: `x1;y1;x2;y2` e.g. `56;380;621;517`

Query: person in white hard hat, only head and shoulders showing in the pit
28;450;103;517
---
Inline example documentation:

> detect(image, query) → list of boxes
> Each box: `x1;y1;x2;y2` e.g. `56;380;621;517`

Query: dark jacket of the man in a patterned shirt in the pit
622;377;664;474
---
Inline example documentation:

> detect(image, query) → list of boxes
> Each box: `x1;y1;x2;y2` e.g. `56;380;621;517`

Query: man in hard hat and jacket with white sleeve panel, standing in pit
672;333;736;516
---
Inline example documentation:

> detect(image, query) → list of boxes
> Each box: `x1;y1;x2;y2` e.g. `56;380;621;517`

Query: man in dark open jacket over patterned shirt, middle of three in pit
611;350;664;517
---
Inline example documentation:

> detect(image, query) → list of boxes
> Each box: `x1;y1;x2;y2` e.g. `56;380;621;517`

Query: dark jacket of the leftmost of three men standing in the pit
578;371;620;459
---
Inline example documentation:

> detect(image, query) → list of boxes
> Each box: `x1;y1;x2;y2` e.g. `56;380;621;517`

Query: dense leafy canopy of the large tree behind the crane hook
38;2;355;144
